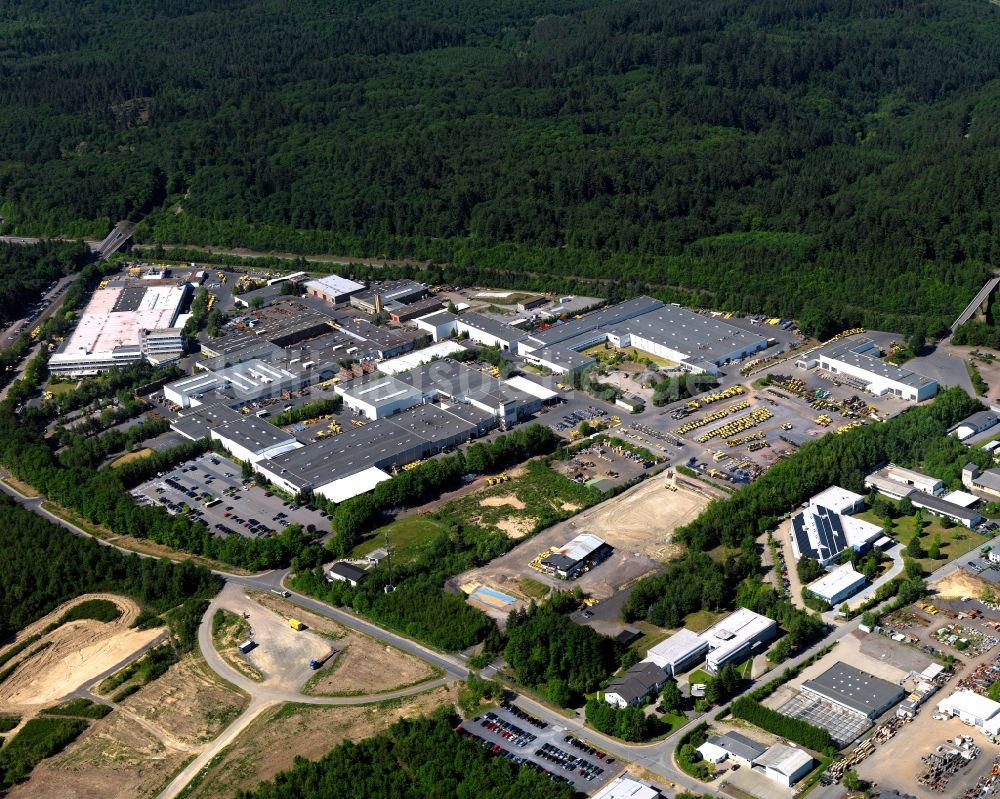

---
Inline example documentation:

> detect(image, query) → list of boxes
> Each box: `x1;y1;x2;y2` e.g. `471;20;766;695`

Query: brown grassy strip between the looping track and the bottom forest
182;686;457;799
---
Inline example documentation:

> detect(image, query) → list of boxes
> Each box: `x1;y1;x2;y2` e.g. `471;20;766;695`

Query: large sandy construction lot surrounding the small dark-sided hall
453;472;714;621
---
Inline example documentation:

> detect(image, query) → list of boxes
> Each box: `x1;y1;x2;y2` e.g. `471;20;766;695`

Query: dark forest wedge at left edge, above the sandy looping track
0;494;222;642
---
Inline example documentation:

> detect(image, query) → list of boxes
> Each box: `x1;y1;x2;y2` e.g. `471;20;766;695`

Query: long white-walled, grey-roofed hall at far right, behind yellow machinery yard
797;337;938;402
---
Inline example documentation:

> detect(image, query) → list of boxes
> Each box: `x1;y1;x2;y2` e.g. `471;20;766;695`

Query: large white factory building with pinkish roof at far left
49;281;190;376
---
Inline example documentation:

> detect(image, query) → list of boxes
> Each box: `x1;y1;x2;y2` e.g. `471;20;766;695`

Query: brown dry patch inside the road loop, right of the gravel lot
251;593;437;696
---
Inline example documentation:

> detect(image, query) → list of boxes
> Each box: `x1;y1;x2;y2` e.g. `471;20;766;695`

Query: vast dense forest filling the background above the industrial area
0;0;1000;334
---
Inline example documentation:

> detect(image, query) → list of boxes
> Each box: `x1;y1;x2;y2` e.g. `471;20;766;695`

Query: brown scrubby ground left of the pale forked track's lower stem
10;656;248;799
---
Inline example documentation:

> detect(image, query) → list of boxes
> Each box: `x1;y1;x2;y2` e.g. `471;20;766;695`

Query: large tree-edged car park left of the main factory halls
132;453;330;537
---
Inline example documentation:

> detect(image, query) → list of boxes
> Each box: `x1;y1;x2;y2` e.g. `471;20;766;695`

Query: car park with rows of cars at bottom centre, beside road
458;702;621;793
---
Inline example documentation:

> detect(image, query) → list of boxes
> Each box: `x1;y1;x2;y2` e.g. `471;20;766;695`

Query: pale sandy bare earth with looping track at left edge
0;594;163;708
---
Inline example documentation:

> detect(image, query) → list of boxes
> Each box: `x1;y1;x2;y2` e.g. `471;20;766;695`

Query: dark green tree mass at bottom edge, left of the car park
239;711;573;799
